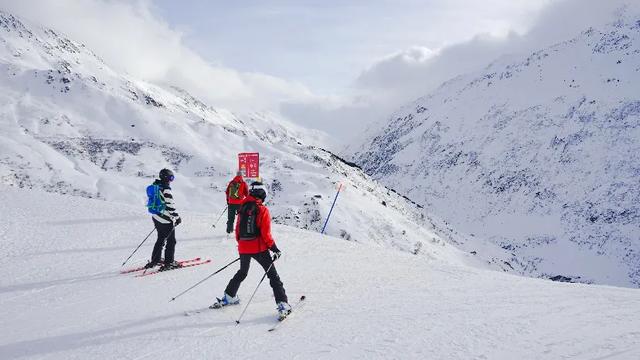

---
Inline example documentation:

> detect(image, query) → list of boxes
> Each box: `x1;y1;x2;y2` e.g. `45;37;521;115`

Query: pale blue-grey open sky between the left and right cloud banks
153;0;548;95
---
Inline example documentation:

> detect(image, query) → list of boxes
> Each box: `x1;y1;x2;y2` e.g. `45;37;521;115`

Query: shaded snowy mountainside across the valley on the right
353;6;640;286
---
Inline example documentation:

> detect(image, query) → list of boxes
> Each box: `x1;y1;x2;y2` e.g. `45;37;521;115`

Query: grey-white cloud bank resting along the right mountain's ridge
283;0;640;148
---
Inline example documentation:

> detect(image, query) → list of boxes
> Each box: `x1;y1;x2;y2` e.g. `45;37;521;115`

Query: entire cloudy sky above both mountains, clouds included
0;0;631;149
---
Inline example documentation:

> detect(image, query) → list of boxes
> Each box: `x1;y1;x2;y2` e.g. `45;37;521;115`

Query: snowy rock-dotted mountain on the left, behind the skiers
0;13;462;254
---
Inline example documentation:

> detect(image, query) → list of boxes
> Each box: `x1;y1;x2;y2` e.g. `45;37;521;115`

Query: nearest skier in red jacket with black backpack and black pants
211;182;291;318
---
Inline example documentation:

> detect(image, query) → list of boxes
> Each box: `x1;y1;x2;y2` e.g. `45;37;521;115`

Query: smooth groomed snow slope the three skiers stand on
0;187;640;360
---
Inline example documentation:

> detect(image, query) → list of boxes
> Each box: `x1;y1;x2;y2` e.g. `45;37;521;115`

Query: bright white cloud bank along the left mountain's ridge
0;0;310;110
